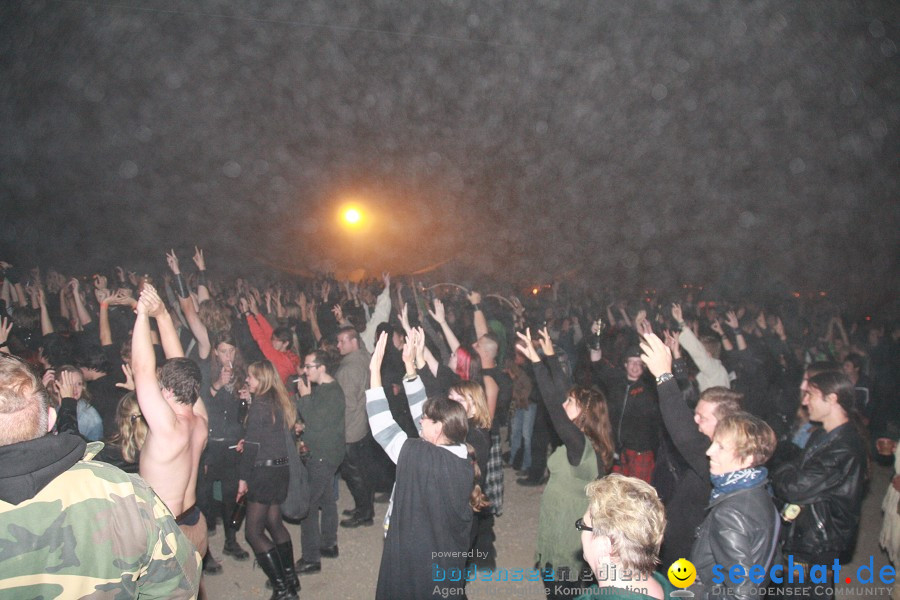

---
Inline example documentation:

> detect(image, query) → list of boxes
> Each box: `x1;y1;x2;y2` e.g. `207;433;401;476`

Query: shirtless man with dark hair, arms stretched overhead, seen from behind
131;284;209;556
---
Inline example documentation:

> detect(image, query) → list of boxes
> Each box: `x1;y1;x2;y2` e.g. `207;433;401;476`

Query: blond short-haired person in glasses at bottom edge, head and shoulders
575;473;673;600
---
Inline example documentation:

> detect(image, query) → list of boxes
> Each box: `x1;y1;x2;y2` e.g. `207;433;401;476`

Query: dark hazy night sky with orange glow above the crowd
0;0;900;310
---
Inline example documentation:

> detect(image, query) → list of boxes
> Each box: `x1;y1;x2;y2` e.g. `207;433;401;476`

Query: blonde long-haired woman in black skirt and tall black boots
237;361;300;600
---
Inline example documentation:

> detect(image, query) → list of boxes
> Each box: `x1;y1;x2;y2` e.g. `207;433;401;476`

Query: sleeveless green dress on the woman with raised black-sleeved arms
535;436;598;574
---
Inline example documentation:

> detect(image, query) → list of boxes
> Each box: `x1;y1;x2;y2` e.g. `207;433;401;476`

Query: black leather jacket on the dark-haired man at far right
772;423;867;564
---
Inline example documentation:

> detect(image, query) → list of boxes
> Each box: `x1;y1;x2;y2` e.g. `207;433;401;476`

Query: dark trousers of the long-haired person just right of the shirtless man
197;441;241;540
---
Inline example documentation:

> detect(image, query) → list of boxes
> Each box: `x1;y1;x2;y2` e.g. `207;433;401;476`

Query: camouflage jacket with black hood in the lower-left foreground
0;434;200;600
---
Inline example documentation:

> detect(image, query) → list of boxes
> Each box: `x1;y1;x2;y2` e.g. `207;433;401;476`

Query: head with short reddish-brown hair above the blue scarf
706;412;778;475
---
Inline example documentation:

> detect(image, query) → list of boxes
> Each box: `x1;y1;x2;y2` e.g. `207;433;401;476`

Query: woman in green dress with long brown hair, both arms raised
516;327;613;598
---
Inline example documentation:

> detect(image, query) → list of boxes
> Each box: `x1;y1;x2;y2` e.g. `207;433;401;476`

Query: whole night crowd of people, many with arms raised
0;249;900;600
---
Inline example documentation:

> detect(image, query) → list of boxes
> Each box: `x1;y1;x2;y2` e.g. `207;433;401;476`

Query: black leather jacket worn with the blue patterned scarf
691;480;780;600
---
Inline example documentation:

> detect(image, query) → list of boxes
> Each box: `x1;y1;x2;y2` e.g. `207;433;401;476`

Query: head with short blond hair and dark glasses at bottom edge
581;473;666;575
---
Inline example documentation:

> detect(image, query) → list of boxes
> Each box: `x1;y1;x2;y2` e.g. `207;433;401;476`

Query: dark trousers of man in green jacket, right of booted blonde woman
300;458;337;562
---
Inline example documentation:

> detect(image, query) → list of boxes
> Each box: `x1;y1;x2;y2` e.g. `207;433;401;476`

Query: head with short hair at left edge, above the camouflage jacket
0;354;56;446
